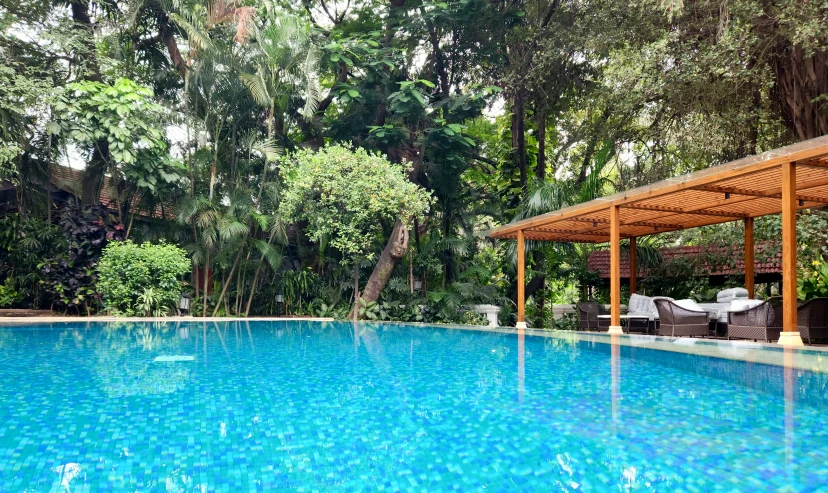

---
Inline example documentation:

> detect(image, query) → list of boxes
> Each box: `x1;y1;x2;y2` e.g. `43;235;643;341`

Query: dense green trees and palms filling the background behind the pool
0;0;828;326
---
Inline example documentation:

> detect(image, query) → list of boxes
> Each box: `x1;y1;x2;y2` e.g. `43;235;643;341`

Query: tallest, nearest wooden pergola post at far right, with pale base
779;162;803;346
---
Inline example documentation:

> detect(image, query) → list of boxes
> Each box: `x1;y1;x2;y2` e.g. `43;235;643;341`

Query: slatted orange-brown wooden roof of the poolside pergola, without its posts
489;136;828;243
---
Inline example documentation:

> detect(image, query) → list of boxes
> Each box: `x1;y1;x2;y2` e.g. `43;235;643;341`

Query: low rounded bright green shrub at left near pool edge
97;240;190;316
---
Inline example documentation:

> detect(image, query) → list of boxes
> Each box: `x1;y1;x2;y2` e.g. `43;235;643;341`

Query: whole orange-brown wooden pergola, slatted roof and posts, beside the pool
489;136;828;345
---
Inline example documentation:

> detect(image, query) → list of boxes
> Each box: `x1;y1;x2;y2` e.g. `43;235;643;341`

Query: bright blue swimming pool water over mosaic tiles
0;322;828;492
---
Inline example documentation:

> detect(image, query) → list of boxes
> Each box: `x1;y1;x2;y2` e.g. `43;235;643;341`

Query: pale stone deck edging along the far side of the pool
0;316;828;373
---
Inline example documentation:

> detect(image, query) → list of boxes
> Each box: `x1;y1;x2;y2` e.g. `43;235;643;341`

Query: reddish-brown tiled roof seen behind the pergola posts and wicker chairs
587;242;782;279
